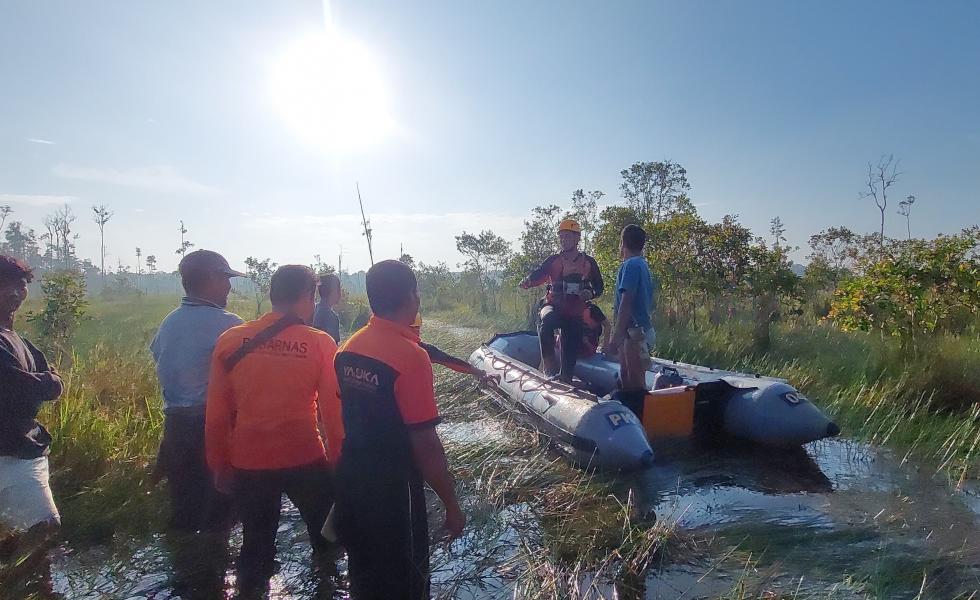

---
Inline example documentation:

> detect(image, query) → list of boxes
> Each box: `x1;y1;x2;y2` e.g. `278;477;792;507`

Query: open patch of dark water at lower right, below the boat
632;440;980;598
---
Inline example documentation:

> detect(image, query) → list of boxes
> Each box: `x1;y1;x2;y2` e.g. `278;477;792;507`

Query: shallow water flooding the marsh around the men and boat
9;323;980;600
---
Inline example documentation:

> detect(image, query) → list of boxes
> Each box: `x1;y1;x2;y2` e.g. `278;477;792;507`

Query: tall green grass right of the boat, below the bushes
657;324;980;483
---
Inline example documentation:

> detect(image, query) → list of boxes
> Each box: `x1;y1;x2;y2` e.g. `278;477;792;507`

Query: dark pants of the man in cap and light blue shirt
157;413;232;532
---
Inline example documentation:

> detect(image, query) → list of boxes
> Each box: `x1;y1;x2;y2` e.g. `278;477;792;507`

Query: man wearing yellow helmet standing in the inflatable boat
520;219;603;381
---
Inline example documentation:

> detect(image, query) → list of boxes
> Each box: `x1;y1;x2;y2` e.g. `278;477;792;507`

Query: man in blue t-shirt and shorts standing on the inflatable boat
609;225;657;391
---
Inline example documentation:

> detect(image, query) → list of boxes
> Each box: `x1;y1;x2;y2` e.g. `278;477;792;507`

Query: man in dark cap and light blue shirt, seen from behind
150;250;245;533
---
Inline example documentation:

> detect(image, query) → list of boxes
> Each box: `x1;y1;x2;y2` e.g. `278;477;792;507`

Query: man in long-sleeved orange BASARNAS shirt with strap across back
205;265;343;593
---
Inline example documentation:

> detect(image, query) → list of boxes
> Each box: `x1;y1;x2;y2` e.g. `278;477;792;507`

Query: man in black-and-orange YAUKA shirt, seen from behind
335;260;465;600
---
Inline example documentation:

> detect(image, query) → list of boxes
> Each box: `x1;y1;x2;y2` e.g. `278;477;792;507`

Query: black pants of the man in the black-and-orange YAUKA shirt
336;467;429;600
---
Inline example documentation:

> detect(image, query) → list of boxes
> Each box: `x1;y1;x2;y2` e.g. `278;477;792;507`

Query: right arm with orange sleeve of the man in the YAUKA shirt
395;349;466;538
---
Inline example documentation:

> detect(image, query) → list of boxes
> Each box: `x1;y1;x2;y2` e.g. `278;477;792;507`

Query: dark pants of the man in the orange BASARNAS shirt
235;459;333;586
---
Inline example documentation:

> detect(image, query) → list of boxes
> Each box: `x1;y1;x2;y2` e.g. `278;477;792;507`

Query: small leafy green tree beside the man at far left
27;271;88;363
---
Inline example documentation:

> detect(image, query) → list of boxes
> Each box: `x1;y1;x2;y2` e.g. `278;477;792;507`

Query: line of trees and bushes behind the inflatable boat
407;156;980;352
